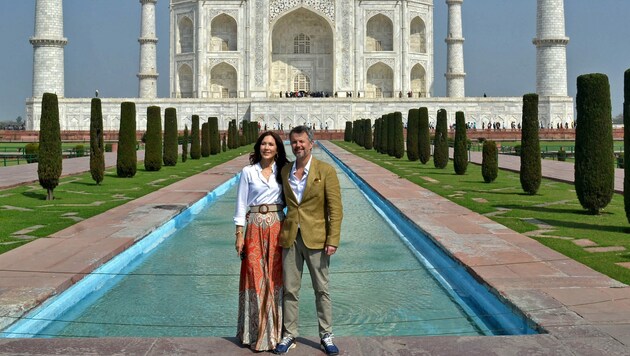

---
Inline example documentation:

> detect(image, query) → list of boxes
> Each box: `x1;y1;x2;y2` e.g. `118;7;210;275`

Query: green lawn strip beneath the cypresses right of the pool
334;141;630;284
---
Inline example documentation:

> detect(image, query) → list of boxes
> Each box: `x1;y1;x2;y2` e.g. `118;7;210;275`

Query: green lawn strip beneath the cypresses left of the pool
0;145;253;253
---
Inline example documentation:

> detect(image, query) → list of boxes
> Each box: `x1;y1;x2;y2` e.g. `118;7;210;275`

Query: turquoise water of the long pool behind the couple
29;150;484;337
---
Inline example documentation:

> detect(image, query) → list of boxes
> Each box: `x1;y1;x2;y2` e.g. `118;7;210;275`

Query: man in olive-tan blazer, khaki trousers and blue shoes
274;126;343;355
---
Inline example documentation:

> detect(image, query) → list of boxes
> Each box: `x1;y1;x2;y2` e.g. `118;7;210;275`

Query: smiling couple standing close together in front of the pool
234;126;343;355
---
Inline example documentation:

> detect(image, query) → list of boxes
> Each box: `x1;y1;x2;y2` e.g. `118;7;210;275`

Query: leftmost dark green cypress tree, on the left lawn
37;93;62;200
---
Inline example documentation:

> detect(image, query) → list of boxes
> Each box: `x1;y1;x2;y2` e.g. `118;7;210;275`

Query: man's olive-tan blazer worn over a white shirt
280;157;343;249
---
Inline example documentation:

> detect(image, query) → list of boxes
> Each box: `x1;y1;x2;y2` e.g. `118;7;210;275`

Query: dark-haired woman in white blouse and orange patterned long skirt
234;131;287;351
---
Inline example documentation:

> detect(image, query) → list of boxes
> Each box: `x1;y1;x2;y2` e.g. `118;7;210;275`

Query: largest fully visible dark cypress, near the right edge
575;73;615;214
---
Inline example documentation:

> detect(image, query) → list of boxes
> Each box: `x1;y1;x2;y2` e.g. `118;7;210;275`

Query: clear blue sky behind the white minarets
0;0;630;121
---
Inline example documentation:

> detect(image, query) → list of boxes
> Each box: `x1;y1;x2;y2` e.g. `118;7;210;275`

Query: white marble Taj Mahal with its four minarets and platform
26;0;573;130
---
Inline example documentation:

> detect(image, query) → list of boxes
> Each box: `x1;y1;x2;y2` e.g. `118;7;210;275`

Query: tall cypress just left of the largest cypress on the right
519;94;542;195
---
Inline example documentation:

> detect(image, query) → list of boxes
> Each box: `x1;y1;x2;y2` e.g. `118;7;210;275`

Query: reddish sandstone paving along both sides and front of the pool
0;141;630;355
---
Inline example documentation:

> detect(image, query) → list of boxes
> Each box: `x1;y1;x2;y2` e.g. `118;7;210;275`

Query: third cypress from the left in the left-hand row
116;101;138;178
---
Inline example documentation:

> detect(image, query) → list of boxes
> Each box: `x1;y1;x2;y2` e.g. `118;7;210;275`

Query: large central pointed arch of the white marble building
269;7;335;96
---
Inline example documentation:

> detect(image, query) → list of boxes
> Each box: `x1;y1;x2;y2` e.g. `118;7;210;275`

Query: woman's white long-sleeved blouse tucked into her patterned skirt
234;162;284;226
